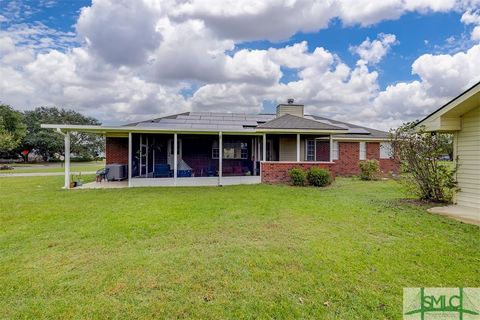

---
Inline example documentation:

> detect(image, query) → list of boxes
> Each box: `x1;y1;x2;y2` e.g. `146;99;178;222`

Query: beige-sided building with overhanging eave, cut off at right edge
417;82;480;211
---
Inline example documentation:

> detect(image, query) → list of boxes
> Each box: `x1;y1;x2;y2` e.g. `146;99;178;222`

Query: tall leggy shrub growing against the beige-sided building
391;122;456;202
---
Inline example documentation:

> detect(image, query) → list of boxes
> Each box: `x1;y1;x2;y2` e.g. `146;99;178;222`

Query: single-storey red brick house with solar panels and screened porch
42;100;398;186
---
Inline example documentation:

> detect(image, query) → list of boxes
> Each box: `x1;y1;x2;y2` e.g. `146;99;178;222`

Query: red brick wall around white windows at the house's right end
335;142;399;176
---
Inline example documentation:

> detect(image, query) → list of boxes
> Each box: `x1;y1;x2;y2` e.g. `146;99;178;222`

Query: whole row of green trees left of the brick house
0;104;105;161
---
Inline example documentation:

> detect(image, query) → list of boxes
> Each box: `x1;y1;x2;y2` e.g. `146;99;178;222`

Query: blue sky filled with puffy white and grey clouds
0;0;480;127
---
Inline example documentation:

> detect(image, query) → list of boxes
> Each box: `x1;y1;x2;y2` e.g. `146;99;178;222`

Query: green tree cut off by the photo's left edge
0;104;27;153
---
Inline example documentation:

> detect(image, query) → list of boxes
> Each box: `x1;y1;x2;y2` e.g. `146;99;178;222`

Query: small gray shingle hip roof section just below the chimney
258;114;345;130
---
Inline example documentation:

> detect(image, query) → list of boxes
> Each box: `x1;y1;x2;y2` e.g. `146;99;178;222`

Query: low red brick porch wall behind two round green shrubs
261;161;335;183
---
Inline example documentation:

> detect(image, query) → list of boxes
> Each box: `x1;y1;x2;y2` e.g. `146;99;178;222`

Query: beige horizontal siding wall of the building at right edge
455;107;480;208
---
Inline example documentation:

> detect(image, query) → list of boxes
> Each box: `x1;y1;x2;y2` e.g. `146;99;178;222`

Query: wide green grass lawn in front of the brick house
0;177;480;319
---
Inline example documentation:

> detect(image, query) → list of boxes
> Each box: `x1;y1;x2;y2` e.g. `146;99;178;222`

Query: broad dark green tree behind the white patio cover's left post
24;107;104;160
